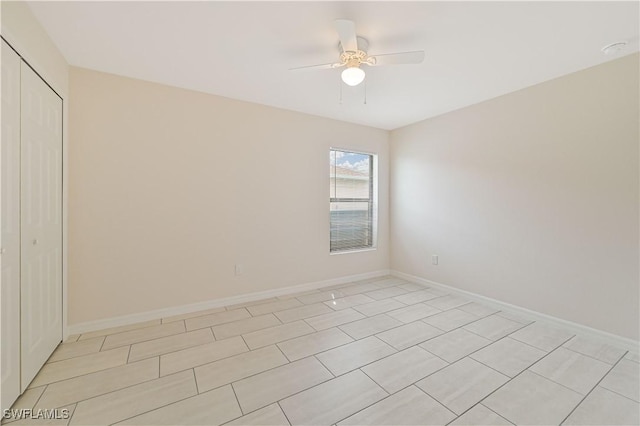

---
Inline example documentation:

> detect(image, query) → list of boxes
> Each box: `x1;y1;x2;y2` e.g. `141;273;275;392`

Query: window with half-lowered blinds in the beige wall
329;149;376;253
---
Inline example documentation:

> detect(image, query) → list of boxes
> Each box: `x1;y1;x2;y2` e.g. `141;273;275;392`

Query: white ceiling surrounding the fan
29;1;640;129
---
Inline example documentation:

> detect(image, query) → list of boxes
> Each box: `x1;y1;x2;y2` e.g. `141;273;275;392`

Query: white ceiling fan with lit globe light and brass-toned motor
290;19;424;86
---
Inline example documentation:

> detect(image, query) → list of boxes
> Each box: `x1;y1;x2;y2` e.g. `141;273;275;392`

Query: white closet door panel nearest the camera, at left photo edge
0;41;20;409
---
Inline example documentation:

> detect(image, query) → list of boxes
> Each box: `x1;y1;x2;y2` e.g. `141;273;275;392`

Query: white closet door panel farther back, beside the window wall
20;56;62;390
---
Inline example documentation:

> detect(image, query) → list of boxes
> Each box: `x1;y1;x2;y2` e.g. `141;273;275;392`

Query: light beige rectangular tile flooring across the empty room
6;277;640;425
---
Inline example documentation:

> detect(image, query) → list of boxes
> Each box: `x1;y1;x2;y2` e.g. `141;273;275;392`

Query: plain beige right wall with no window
390;54;640;340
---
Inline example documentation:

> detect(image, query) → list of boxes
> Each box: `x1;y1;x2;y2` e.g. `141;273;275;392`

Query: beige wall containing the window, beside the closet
69;67;389;324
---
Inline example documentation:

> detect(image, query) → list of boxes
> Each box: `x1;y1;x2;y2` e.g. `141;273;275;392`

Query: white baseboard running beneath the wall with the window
64;269;390;340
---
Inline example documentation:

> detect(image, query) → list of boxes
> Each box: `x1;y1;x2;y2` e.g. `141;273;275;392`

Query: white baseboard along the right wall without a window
391;270;640;353
